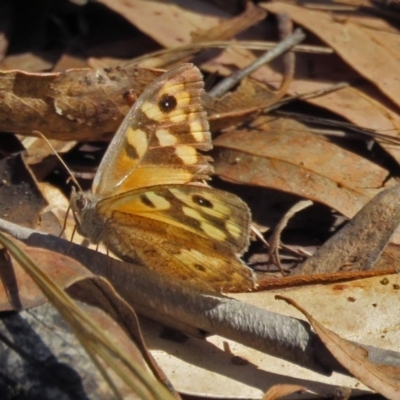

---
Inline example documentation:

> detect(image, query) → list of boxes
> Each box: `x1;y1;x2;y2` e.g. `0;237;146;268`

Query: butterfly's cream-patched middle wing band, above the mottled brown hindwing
97;185;250;254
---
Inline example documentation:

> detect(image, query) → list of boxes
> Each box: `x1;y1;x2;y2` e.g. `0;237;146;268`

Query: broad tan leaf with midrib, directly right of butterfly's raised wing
213;117;395;218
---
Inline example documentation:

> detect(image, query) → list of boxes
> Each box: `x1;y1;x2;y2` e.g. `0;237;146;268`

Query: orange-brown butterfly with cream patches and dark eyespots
71;64;254;292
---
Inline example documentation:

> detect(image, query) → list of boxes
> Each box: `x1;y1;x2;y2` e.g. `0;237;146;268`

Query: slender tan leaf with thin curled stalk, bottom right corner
275;295;400;400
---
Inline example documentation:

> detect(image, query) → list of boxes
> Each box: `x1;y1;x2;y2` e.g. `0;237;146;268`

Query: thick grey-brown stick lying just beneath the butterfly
0;219;400;373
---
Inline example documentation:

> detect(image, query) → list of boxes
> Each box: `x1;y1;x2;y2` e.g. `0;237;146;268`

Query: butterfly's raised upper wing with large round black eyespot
93;64;212;196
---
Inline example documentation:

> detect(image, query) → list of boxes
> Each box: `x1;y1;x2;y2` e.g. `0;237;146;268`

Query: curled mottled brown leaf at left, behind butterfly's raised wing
0;66;161;140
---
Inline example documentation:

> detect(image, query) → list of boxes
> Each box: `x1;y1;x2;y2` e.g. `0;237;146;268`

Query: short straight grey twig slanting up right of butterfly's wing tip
208;28;306;98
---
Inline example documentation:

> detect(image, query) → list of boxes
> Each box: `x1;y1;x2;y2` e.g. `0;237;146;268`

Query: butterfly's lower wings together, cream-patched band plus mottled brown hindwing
98;185;252;291
